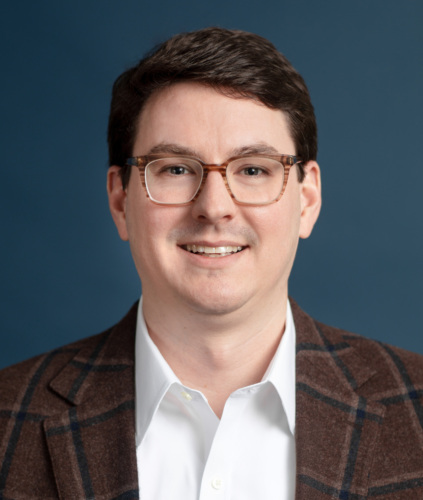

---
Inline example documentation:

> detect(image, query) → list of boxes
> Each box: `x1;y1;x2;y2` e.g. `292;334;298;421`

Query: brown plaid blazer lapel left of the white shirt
44;305;139;499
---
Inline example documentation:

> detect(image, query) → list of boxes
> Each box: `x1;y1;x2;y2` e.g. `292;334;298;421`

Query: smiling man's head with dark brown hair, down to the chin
108;29;320;321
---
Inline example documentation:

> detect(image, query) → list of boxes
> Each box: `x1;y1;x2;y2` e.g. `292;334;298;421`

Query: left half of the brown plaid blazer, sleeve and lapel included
0;305;139;500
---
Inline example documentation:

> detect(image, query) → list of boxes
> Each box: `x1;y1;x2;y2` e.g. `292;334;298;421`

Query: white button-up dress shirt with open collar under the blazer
135;300;295;500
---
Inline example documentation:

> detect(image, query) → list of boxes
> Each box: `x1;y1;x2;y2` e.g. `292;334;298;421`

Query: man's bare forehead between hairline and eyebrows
133;83;295;161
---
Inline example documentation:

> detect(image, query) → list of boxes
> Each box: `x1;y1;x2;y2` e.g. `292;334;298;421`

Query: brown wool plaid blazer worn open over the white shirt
0;301;423;500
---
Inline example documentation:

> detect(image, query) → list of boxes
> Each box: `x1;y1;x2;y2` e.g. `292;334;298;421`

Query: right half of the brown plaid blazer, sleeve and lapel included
291;301;423;500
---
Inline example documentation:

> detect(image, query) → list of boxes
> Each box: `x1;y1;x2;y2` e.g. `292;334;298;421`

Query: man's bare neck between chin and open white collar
143;295;287;418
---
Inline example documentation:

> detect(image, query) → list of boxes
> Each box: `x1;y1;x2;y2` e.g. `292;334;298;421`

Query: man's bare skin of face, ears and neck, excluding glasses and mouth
107;83;321;417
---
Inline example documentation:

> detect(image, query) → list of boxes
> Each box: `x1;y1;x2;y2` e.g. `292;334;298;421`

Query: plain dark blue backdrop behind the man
0;0;423;366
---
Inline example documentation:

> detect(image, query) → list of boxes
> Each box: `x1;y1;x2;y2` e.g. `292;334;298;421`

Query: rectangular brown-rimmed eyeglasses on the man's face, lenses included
126;155;301;205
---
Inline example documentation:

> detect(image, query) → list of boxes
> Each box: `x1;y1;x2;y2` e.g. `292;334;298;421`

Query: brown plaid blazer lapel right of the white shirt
291;301;384;500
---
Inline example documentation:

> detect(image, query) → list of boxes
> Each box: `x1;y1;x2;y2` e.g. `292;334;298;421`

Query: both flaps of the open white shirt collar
135;297;295;445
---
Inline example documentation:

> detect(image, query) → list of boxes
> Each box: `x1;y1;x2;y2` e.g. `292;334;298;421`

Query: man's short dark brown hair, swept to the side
108;28;317;185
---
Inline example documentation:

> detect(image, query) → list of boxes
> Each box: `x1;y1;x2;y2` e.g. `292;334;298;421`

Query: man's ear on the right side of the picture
300;160;322;238
